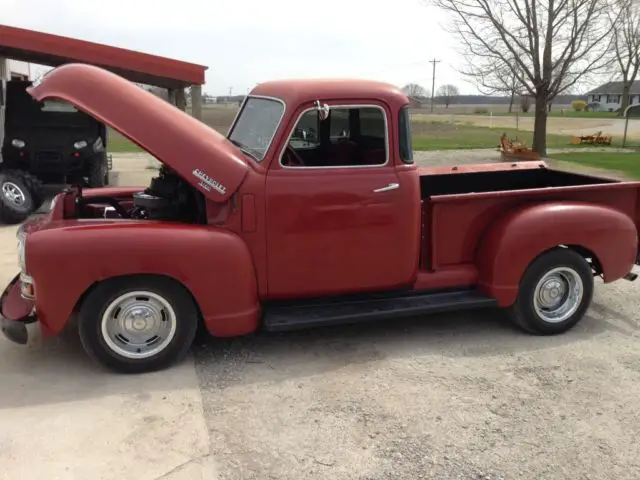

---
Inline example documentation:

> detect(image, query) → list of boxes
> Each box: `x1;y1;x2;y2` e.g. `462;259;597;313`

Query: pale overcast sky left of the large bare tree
0;0;475;95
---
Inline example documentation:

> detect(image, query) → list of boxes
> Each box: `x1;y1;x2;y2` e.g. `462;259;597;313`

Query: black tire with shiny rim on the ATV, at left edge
0;170;44;224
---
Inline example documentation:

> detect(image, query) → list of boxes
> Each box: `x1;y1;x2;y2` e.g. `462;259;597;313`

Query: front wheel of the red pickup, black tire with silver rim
78;276;199;373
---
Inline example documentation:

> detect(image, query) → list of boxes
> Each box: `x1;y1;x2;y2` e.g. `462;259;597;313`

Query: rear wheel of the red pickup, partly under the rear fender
509;248;593;335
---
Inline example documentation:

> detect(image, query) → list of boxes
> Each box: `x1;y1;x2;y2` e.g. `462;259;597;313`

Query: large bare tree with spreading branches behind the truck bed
427;0;615;156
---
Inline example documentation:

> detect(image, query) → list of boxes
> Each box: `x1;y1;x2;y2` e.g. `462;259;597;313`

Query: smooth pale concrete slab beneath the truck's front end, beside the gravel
0;227;215;480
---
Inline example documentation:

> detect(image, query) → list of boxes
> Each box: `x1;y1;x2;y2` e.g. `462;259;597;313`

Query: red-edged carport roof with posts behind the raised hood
0;25;207;119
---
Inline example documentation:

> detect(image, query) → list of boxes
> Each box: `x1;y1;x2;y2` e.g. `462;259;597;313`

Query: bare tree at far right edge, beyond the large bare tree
609;0;640;115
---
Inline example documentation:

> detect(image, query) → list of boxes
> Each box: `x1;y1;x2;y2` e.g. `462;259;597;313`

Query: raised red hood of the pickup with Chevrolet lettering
28;64;248;202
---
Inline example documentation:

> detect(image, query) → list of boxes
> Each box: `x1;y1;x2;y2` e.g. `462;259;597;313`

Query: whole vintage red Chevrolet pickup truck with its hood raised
1;64;640;372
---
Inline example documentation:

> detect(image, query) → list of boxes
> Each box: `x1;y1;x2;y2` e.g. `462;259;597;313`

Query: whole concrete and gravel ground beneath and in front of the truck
0;153;640;480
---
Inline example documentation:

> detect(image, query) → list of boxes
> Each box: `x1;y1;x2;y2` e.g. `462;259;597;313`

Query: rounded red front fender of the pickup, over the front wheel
26;221;260;336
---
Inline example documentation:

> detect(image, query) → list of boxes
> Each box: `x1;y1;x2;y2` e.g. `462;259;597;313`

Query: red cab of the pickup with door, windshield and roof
229;81;420;298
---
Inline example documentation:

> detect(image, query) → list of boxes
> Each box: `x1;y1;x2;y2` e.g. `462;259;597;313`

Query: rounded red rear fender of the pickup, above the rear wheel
476;202;638;306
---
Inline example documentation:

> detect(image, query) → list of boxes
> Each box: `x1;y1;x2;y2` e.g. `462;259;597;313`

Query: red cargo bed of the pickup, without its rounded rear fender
419;162;640;274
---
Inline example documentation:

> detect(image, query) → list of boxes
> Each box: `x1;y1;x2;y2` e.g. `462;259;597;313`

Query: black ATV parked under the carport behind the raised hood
0;80;111;223
